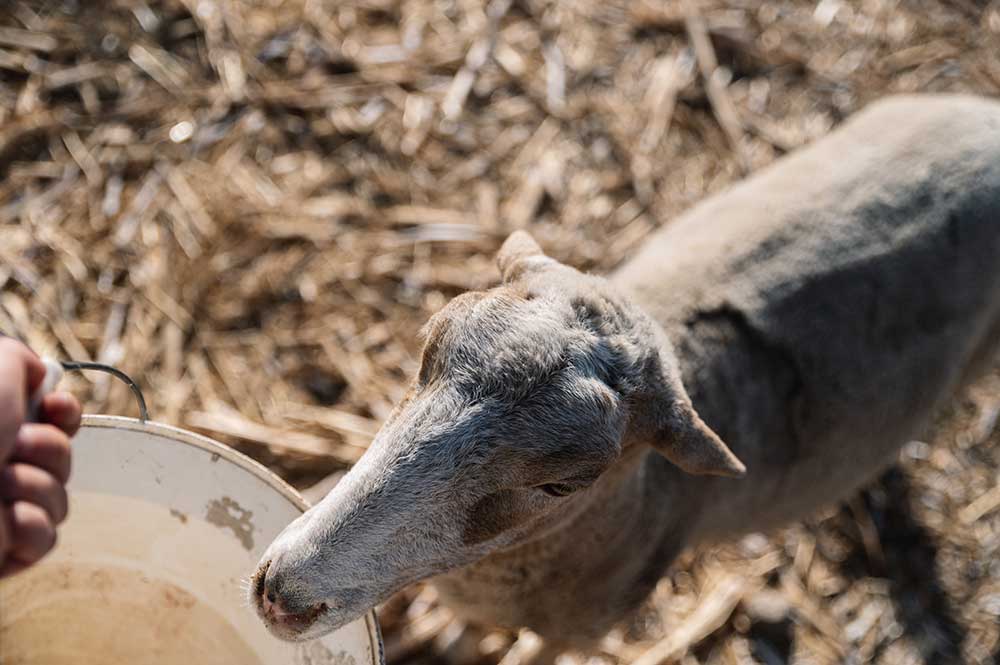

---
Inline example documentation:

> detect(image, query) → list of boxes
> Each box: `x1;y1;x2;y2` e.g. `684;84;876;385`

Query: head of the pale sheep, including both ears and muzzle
250;232;743;640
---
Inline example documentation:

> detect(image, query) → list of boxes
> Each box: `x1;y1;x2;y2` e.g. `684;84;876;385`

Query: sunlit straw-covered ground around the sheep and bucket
0;0;1000;665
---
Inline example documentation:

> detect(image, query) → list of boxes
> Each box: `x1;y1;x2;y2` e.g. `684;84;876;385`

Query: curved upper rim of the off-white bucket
80;414;385;665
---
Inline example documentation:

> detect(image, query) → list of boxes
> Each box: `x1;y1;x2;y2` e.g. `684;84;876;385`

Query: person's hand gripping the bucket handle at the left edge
0;338;81;577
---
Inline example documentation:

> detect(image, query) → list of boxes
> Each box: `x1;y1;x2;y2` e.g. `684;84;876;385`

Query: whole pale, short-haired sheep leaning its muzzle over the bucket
250;96;1000;645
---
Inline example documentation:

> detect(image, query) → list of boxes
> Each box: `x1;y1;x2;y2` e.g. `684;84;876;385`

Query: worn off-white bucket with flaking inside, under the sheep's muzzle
0;416;384;665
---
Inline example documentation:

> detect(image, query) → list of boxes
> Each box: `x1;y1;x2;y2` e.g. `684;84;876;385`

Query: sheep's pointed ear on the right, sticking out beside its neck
653;403;746;478
